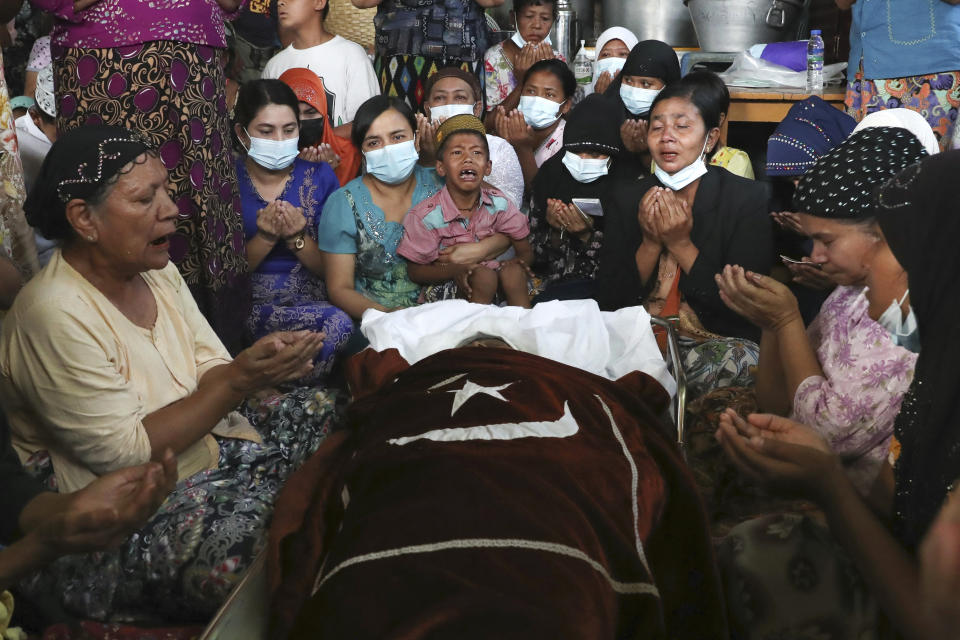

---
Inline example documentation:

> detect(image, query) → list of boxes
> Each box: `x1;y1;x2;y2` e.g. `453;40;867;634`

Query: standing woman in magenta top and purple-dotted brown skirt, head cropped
31;0;250;351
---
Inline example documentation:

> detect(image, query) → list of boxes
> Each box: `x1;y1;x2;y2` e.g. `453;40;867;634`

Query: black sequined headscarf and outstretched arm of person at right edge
717;151;960;640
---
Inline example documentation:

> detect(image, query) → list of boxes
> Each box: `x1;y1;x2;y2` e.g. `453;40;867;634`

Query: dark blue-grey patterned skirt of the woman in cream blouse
19;387;340;624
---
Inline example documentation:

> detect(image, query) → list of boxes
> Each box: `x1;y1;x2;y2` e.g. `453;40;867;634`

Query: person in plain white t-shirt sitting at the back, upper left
263;0;380;138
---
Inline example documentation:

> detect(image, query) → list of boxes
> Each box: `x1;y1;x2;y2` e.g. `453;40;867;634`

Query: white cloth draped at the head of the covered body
360;300;677;397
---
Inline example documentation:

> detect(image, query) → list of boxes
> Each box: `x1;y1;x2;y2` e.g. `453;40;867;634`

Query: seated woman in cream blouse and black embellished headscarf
0;126;344;622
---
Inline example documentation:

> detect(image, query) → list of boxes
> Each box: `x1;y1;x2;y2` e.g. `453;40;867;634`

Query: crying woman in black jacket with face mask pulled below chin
598;80;773;395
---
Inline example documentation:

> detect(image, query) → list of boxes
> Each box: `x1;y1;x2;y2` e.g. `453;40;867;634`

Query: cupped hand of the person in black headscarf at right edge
715;410;844;501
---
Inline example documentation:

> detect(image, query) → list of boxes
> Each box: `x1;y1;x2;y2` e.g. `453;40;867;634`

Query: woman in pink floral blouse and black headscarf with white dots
717;127;926;494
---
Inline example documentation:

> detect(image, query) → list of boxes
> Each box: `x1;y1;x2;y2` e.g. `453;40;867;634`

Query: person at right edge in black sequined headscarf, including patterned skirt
717;152;960;640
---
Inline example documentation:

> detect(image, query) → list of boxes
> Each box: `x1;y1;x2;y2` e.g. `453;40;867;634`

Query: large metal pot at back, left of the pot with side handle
598;0;697;47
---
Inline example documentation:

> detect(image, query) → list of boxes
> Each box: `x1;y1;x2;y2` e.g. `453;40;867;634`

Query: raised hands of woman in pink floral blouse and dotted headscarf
714;265;802;331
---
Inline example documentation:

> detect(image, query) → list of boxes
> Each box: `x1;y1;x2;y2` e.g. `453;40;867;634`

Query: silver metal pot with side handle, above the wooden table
685;0;808;52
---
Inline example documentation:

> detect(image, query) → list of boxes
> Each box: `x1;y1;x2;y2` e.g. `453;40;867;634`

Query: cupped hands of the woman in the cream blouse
227;331;326;397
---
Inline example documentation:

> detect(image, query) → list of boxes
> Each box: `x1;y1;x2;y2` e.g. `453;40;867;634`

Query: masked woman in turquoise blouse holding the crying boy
317;96;504;320
